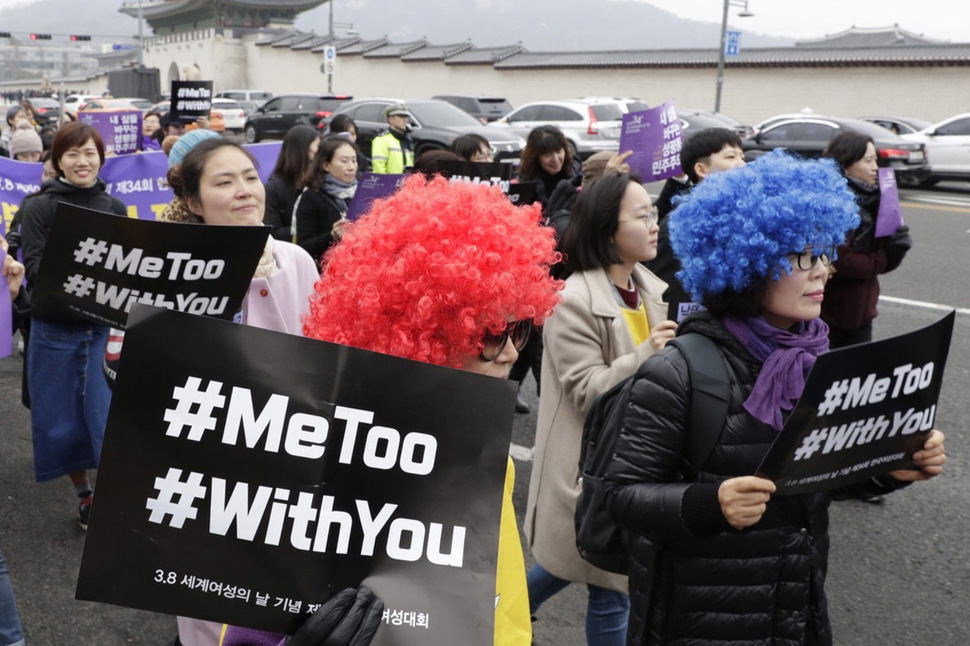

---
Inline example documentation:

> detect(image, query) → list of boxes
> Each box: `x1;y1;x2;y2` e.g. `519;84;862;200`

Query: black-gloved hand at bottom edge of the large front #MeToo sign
286;586;384;646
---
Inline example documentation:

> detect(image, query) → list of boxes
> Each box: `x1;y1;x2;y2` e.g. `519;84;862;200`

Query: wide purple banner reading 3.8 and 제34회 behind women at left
0;141;283;225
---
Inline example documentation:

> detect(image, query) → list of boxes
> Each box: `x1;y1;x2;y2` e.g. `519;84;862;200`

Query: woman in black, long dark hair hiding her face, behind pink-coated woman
263;126;320;242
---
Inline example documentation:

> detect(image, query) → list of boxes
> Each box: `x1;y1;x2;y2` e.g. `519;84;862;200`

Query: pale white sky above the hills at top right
640;0;970;42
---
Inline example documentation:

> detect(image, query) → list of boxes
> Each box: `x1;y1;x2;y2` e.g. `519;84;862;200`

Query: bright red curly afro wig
303;175;563;368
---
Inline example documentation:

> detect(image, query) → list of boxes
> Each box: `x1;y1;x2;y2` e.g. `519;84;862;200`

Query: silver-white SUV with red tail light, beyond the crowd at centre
488;99;623;159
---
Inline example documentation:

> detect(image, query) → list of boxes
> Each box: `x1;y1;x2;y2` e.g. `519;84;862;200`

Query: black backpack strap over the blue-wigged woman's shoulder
668;333;731;480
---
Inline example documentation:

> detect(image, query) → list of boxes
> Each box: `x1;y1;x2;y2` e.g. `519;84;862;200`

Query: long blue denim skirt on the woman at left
27;318;111;482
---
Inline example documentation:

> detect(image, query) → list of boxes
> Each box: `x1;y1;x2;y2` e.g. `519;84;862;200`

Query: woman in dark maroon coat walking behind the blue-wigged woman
822;132;913;348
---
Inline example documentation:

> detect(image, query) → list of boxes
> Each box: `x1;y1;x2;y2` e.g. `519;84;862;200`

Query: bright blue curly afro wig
670;150;859;301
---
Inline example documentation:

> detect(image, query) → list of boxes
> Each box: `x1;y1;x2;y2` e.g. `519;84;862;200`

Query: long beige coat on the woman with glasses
525;265;667;592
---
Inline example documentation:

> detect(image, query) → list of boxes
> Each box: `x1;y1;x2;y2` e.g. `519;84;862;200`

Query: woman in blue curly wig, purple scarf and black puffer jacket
606;152;946;646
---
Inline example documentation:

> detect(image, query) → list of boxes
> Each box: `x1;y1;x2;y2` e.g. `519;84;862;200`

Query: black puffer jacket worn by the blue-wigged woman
606;312;895;646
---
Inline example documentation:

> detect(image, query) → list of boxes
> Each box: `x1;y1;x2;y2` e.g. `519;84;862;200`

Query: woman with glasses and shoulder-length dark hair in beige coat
525;173;676;646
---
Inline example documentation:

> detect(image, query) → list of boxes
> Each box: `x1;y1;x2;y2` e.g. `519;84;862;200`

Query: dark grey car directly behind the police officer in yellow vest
324;98;525;161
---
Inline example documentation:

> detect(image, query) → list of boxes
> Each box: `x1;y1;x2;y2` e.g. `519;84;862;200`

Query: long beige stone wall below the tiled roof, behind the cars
138;31;970;124
